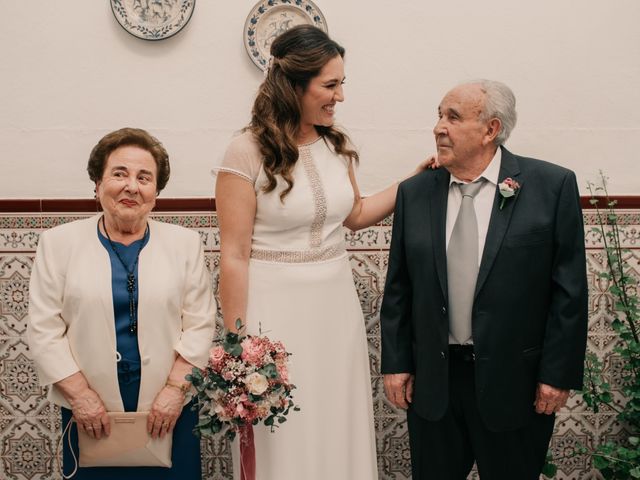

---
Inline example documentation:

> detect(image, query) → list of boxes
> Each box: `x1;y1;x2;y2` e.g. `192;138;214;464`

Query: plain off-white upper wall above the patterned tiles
0;0;640;198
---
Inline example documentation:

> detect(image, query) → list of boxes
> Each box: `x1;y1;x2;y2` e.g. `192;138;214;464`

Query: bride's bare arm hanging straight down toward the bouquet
216;172;256;331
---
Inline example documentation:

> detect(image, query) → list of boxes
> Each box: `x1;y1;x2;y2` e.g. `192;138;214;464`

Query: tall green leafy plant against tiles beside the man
576;171;640;480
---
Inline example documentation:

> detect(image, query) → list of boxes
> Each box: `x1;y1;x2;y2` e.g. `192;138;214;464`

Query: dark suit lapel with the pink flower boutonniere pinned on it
475;147;523;297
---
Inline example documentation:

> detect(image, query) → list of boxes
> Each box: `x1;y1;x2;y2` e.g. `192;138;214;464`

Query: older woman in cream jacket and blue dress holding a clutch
28;128;215;480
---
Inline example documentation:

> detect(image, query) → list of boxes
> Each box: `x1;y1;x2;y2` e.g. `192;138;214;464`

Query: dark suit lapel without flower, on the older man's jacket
429;168;450;299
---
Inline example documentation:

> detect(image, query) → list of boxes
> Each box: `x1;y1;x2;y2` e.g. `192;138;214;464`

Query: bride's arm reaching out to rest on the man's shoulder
344;155;438;231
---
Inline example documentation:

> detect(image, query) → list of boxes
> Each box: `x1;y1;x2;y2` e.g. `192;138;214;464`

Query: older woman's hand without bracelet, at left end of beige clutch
55;372;111;439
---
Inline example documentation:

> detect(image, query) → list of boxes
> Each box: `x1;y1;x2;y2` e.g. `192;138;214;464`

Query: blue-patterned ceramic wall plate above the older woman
111;0;196;40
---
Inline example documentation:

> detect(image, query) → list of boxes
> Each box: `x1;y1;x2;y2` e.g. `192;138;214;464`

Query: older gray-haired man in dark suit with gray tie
381;80;587;480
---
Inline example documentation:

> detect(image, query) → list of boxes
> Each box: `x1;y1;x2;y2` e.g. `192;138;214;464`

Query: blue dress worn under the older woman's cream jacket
62;229;201;480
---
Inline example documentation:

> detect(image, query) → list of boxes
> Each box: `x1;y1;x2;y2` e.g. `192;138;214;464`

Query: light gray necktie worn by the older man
447;178;484;344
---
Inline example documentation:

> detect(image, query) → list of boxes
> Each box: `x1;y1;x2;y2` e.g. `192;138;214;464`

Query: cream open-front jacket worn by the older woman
27;215;216;412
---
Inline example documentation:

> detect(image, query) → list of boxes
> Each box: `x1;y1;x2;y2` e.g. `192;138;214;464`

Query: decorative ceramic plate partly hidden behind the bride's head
244;0;328;71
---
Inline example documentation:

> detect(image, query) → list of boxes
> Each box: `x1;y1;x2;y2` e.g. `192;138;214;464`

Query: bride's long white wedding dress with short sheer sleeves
217;132;378;480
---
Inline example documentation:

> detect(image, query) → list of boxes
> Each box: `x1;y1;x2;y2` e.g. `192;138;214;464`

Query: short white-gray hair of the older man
470;79;518;146
